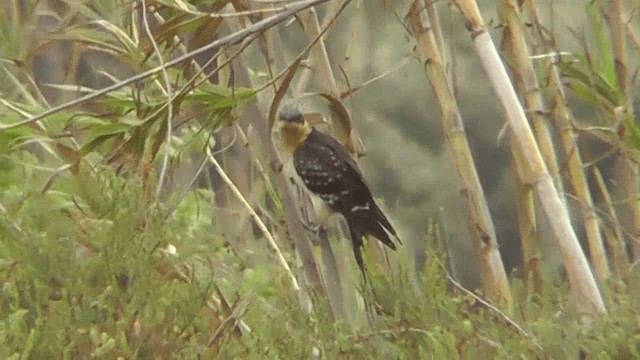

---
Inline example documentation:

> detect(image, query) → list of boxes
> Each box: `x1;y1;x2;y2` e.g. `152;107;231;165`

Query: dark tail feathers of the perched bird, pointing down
345;203;400;282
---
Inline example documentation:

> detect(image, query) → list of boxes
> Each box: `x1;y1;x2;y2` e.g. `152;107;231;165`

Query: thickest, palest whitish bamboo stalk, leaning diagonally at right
451;0;606;314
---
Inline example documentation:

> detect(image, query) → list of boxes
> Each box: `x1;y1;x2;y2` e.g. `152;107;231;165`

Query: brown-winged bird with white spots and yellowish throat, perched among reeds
272;99;402;282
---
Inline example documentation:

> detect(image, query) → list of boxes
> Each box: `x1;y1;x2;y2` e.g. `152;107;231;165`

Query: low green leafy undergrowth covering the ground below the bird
0;166;640;359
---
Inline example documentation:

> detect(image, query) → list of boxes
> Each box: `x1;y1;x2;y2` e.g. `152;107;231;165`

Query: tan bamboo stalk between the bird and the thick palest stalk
407;0;512;311
